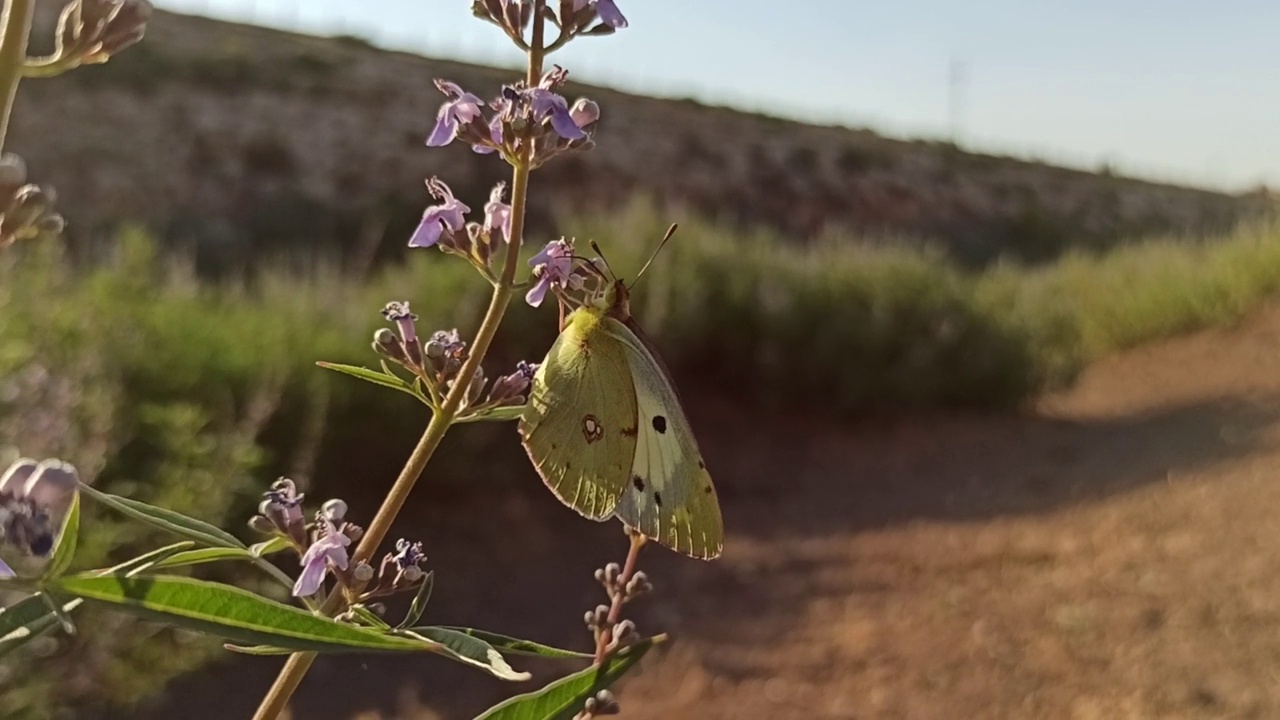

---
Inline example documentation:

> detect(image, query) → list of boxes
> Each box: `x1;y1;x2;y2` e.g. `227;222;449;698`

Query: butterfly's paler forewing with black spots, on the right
603;318;724;560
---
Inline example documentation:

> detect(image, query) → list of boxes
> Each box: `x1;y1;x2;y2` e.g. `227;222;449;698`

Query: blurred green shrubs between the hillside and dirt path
0;194;1280;717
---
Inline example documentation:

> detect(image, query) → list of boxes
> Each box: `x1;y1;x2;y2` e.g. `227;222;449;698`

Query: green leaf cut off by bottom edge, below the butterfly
476;635;667;720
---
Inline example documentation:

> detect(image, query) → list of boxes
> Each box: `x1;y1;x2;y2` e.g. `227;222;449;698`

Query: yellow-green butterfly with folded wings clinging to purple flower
520;225;724;560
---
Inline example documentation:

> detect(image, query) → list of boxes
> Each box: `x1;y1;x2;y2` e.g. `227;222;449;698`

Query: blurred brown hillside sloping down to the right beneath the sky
12;13;1263;269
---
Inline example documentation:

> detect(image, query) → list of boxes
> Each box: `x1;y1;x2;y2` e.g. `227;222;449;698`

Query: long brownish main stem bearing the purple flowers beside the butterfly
253;0;545;720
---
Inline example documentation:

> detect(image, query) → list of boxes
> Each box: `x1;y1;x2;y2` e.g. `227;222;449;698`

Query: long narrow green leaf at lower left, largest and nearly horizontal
51;573;442;652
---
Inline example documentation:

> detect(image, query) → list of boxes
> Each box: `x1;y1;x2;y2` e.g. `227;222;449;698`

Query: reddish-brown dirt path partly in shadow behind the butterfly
145;307;1280;720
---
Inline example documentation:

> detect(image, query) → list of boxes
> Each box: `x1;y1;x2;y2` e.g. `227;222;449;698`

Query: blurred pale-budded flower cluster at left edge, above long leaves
0;457;79;578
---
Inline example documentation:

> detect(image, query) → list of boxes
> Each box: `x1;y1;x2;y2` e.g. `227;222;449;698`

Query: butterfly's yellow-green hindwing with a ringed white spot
520;309;636;520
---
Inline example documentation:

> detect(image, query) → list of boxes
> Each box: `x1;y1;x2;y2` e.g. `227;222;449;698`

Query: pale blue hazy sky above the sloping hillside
156;0;1280;191
